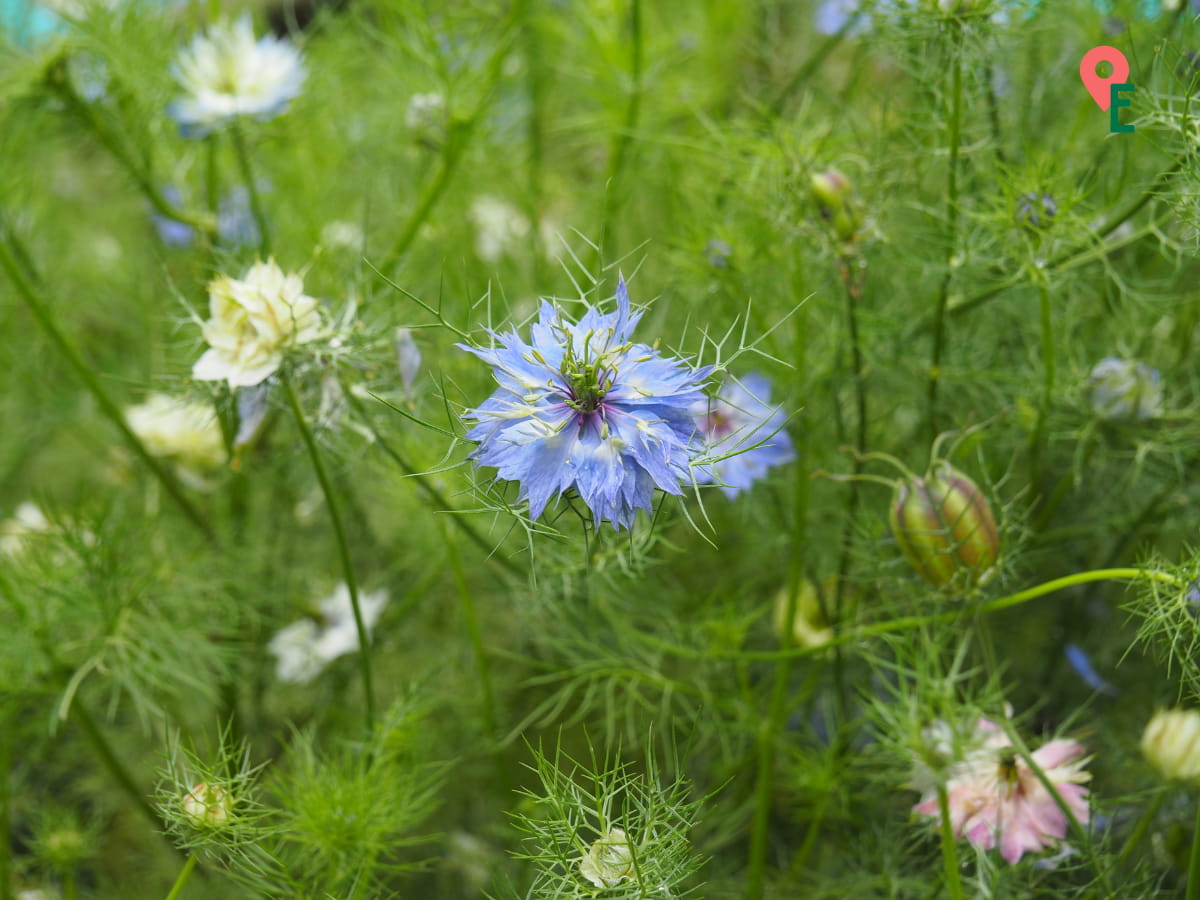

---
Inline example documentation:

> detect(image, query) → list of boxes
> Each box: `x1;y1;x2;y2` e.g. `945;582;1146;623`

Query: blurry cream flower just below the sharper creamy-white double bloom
125;394;227;473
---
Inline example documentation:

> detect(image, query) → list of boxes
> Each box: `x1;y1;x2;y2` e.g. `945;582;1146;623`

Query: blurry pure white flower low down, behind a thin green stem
268;583;388;684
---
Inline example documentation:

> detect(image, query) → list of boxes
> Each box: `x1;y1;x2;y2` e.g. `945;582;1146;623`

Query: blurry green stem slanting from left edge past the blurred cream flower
0;222;216;544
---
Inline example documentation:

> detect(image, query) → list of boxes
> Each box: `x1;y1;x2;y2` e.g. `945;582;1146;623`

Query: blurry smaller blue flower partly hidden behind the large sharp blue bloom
691;372;796;498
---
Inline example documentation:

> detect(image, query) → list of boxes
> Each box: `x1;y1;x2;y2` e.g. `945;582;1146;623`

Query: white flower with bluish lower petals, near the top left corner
167;14;305;137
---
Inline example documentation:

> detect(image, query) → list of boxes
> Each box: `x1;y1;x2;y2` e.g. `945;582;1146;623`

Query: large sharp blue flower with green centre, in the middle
458;278;713;529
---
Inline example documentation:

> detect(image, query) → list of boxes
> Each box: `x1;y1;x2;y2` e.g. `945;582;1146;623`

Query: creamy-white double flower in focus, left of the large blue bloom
192;259;322;388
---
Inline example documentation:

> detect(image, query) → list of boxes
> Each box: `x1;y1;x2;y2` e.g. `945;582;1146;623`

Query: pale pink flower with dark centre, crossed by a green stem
913;719;1092;863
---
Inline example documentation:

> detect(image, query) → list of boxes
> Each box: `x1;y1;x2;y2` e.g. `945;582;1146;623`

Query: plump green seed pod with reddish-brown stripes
889;461;1000;588
